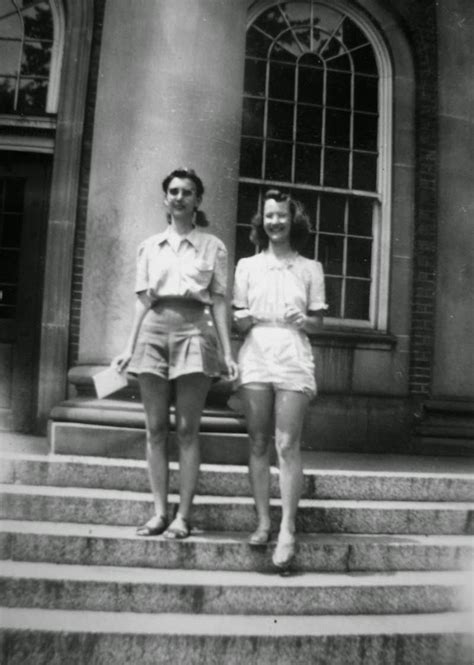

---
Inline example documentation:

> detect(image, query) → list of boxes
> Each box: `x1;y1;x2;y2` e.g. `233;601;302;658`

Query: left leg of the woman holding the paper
138;374;170;523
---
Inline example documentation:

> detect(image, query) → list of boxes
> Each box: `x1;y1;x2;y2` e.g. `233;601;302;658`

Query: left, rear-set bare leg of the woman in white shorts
241;384;274;542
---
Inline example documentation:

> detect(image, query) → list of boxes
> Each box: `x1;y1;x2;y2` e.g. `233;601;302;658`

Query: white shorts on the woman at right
239;324;317;397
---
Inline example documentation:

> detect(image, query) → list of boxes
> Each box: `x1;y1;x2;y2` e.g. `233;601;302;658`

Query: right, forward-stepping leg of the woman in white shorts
274;390;309;563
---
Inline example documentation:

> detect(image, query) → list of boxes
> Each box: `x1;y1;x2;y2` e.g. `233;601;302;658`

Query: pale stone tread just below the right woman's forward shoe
0;561;466;588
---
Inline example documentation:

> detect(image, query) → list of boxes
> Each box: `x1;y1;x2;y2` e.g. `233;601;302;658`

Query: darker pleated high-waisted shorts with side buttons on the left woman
127;298;220;380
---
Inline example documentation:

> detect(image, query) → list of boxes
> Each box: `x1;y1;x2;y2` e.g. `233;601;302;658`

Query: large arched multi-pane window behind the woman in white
236;0;391;330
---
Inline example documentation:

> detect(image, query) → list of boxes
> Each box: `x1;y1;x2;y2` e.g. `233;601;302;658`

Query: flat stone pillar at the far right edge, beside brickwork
432;0;474;400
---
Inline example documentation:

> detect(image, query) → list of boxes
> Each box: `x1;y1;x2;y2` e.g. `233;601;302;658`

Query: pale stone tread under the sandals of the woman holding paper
0;519;474;552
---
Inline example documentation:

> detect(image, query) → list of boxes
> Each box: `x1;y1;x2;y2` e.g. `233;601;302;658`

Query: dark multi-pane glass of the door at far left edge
0;178;25;319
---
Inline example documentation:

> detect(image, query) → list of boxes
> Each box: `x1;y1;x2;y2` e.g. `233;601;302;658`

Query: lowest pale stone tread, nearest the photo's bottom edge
0;607;472;637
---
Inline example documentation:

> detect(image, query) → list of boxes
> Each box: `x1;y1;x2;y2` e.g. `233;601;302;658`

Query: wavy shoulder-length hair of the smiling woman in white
250;189;311;252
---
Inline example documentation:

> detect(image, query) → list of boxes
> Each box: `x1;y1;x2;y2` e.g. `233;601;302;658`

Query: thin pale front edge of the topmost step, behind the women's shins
2;452;474;480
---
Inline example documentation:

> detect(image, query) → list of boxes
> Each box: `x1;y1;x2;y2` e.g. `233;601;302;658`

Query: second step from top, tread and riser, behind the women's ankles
0;484;474;534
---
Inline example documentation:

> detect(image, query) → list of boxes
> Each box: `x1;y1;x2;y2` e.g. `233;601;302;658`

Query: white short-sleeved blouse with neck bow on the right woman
233;251;327;321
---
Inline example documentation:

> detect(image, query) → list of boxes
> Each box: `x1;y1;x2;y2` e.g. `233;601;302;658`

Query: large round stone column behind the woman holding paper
79;0;247;364
